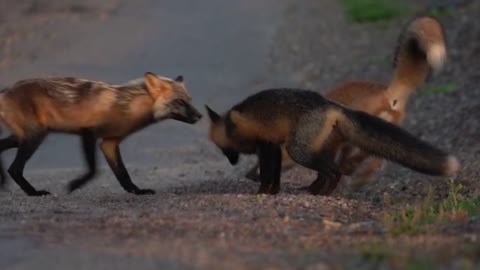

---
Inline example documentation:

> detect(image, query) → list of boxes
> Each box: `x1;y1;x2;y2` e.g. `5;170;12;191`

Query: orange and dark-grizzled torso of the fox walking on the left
0;77;152;136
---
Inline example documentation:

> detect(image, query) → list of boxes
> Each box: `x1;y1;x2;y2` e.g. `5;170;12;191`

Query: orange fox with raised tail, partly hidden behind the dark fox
247;17;447;193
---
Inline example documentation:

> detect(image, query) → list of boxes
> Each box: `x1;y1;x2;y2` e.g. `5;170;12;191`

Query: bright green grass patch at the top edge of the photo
340;0;409;23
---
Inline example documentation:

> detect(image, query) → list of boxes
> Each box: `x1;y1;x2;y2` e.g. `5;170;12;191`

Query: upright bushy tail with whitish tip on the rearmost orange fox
391;17;447;91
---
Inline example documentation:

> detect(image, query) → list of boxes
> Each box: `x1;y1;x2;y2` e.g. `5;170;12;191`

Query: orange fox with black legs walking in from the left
0;72;202;196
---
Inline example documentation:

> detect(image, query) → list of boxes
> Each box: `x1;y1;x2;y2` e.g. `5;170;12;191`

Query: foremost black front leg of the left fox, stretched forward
100;139;155;195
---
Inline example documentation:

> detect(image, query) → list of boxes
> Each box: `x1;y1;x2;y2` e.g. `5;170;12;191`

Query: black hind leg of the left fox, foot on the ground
8;135;50;196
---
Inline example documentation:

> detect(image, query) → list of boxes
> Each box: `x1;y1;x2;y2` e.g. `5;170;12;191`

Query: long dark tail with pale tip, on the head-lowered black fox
338;108;460;175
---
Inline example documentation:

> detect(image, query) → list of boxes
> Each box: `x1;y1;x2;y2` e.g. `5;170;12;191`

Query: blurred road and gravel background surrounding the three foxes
0;0;480;270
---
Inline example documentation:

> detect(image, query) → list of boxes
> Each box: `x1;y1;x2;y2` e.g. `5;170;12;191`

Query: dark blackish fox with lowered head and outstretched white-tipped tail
206;89;460;195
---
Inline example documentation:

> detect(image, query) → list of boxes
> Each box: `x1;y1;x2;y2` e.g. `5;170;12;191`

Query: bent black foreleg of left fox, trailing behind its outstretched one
68;130;97;192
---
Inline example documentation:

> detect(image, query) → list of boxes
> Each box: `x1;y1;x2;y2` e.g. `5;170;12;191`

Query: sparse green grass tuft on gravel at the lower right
384;180;480;235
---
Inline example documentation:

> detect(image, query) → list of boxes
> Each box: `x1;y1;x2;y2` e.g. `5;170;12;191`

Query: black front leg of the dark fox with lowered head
258;143;282;194
